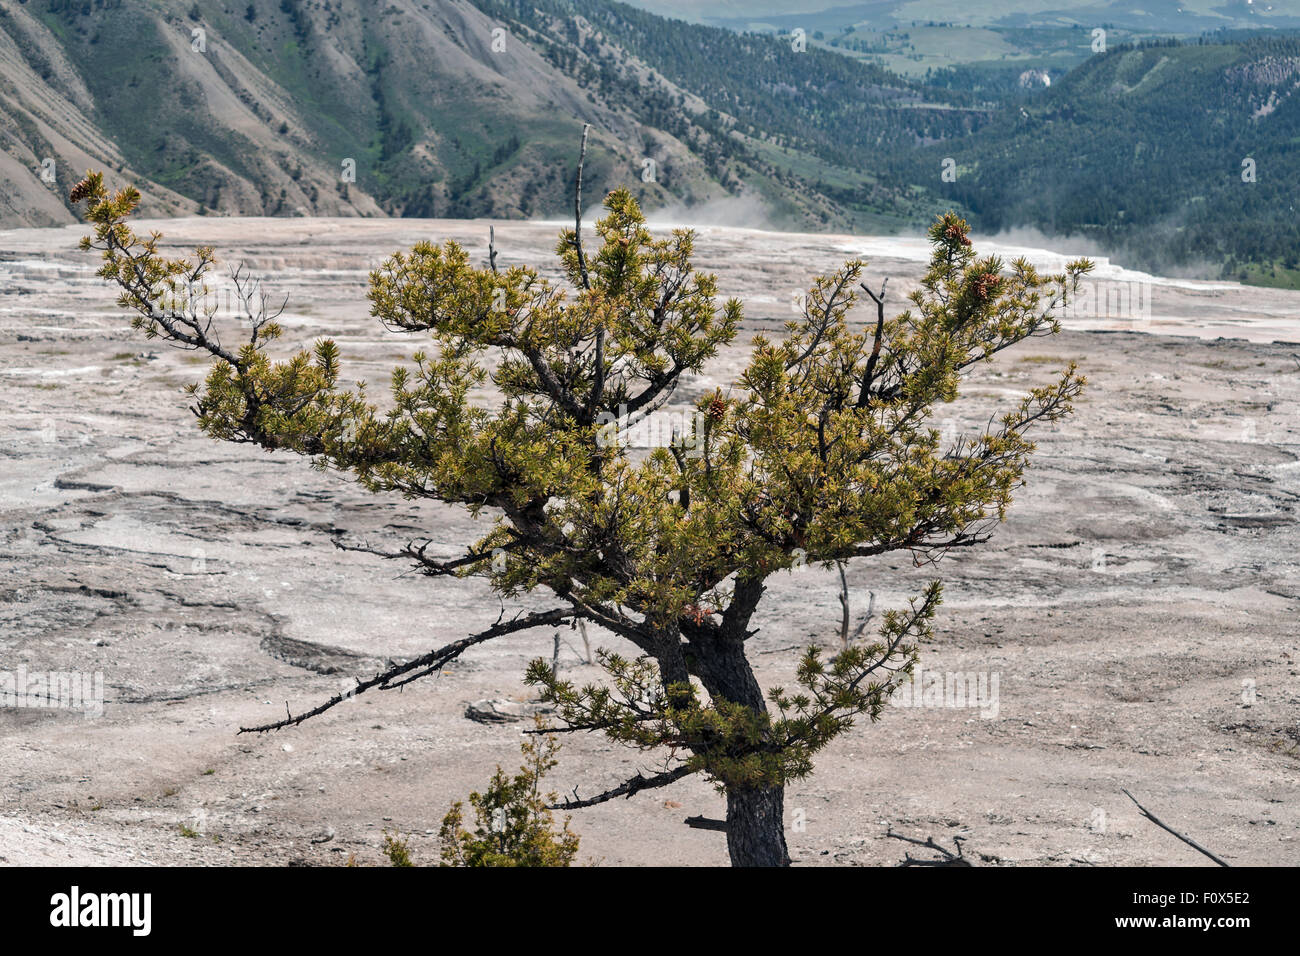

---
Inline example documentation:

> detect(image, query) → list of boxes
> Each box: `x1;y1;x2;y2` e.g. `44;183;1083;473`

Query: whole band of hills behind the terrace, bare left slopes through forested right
0;0;1300;285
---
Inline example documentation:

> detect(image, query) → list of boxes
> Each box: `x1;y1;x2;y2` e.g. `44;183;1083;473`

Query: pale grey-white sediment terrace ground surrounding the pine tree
0;219;1300;865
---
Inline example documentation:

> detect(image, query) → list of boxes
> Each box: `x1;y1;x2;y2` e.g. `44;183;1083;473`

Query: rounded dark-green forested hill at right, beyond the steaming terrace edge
892;35;1300;285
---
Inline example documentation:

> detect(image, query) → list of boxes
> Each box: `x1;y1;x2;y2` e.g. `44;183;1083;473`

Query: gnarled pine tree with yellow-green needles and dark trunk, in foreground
72;166;1091;865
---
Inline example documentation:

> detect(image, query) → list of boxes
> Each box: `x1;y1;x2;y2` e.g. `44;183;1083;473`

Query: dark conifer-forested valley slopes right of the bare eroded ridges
491;0;1300;285
